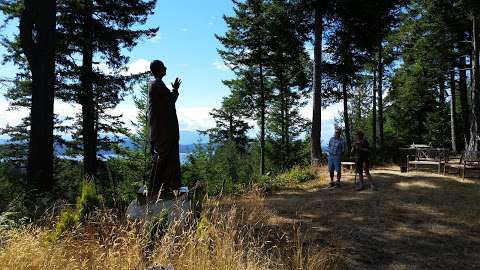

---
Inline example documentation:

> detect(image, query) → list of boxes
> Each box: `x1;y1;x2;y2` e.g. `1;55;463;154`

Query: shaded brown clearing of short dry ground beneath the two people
265;170;480;269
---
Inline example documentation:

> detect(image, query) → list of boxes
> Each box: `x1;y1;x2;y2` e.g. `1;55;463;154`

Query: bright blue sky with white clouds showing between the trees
0;0;338;146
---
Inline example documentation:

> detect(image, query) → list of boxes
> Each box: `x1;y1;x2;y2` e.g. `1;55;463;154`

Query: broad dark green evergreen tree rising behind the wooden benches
389;0;468;146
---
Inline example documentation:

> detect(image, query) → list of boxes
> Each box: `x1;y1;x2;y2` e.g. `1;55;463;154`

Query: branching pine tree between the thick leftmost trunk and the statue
59;0;158;175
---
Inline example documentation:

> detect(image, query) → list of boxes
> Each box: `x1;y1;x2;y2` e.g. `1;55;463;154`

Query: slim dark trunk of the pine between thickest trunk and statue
80;0;97;176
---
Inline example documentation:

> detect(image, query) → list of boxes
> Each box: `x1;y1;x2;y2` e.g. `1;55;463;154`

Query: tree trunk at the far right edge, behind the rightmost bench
468;15;480;151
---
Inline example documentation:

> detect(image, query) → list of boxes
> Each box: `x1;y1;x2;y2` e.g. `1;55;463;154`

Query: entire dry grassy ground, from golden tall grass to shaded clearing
0;169;480;270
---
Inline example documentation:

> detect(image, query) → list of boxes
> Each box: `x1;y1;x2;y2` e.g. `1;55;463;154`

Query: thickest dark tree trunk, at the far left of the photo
19;0;56;191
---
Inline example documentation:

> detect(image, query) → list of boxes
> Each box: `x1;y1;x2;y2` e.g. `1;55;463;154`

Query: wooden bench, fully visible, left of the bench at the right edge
407;148;448;174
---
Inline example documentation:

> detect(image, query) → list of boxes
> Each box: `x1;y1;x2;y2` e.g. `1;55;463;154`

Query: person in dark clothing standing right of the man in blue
352;130;375;190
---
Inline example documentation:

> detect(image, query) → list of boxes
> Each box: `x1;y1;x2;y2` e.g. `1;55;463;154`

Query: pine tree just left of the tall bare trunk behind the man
267;0;310;170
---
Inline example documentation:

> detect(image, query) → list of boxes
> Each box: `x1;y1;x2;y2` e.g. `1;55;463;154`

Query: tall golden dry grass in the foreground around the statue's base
0;188;342;270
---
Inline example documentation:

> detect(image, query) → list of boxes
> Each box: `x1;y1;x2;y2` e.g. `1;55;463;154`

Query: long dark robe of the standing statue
148;79;181;194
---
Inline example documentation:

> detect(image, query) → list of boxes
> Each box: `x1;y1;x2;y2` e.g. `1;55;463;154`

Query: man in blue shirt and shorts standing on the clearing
328;127;345;187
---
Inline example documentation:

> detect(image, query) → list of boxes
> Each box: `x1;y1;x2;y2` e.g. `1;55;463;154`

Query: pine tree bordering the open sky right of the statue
216;0;269;174
